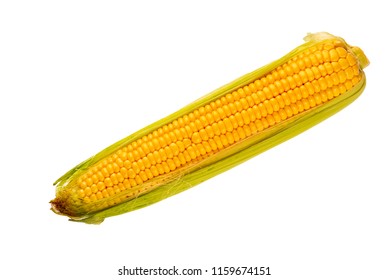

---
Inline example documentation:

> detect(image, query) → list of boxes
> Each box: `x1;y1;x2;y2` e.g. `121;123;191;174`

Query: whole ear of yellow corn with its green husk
51;33;369;223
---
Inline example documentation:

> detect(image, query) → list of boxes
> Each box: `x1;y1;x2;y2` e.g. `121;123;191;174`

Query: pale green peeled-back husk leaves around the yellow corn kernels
52;32;369;224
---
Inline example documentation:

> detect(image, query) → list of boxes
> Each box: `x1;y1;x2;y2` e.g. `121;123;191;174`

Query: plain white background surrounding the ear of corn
0;0;389;280
